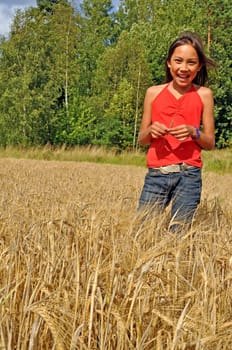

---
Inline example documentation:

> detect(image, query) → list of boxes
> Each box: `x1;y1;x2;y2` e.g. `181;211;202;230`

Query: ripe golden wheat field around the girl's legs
0;159;232;350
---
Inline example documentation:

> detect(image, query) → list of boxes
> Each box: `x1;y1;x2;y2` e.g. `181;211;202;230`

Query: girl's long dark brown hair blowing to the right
165;32;216;86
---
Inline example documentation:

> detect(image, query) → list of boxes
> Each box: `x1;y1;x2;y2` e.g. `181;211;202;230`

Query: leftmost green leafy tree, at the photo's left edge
0;9;43;144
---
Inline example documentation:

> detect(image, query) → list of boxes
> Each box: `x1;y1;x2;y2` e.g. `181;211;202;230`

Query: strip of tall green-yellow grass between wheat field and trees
0;146;232;174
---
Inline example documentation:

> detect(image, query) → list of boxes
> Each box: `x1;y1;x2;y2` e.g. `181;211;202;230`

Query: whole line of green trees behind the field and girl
0;0;232;150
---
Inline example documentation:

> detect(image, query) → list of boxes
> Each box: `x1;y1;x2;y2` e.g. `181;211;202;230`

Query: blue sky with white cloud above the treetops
0;0;120;35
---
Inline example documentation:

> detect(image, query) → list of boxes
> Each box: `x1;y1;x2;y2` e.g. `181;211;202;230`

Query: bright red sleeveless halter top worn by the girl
147;84;203;168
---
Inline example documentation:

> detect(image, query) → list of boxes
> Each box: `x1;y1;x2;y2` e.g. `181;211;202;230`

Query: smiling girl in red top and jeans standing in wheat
139;32;215;231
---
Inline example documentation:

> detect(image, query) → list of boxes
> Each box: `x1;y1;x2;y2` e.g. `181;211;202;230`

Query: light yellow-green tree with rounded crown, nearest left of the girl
93;24;151;148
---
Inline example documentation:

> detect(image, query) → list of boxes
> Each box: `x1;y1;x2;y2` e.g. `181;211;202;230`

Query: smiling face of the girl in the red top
167;44;201;89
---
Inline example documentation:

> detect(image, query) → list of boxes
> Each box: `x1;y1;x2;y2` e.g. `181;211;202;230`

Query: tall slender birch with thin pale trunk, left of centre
45;4;80;143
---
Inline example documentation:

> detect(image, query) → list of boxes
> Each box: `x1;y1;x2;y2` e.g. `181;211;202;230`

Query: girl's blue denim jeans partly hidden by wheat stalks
139;166;202;228
